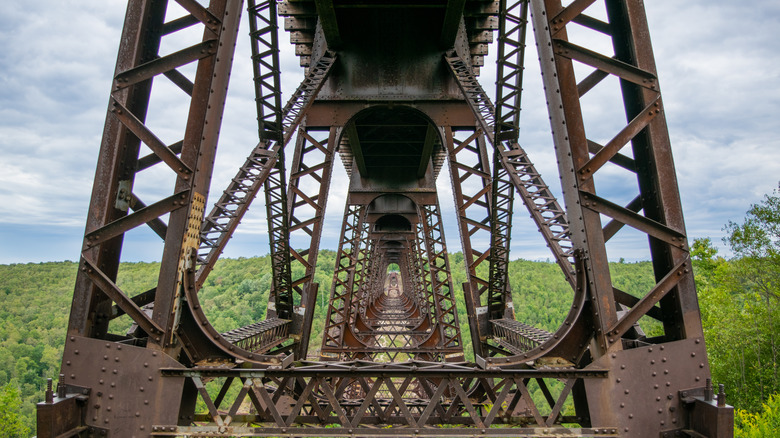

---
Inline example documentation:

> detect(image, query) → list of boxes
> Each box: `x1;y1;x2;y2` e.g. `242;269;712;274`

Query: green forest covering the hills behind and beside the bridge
0;186;780;437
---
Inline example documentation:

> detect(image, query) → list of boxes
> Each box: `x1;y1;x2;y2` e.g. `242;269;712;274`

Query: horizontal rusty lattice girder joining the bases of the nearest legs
152;361;618;436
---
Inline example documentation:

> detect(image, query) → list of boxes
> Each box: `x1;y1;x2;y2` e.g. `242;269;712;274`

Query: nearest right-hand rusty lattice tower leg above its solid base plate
534;2;701;348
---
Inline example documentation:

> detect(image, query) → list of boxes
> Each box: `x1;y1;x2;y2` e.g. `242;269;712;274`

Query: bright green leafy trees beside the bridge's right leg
691;185;780;412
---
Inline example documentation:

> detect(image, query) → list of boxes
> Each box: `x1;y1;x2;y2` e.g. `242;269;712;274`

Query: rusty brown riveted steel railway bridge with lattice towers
38;0;733;437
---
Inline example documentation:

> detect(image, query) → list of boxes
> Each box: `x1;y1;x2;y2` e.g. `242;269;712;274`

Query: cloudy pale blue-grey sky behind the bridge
0;0;780;264
